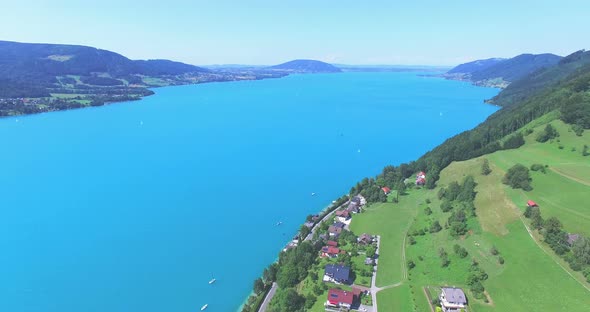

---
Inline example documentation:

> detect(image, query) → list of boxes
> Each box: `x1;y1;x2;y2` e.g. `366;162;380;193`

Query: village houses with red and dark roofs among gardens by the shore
268;172;476;312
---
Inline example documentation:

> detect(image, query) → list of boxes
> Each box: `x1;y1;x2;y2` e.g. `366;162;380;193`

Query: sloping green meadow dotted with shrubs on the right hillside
360;118;590;312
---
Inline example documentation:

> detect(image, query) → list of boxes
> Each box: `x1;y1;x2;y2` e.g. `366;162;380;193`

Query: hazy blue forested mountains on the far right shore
444;53;562;88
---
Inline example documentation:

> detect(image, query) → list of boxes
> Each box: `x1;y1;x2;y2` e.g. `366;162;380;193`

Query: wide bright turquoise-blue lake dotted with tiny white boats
0;73;498;312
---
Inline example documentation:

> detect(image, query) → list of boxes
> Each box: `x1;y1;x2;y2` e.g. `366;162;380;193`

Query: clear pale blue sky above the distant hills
0;0;590;65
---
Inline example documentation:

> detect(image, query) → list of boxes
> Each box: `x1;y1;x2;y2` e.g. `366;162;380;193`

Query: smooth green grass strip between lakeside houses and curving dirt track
350;195;425;287
